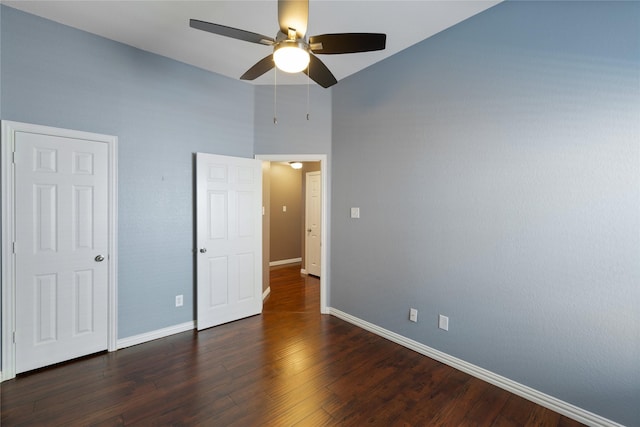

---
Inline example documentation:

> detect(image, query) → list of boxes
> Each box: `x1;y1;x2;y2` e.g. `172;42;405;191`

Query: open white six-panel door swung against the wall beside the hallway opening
196;153;262;330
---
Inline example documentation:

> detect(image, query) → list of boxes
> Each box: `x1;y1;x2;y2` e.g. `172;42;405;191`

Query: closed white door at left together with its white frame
1;121;117;380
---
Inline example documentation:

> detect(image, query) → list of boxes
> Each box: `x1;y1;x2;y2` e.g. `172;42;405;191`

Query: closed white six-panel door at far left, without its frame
14;132;109;373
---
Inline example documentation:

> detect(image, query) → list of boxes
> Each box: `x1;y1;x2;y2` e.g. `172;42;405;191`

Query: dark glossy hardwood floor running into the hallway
1;265;581;427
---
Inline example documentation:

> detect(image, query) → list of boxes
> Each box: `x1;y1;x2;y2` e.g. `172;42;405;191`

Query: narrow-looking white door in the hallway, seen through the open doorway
305;172;322;277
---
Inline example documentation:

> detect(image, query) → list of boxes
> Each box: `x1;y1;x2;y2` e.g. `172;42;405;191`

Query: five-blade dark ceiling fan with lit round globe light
189;0;387;88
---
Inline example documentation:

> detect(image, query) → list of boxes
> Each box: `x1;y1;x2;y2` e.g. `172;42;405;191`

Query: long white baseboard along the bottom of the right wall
328;307;623;427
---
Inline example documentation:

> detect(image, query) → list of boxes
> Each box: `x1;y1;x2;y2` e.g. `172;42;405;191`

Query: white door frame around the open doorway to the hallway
255;154;331;314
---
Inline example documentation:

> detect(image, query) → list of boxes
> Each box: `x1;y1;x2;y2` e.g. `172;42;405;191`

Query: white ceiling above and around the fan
1;0;500;84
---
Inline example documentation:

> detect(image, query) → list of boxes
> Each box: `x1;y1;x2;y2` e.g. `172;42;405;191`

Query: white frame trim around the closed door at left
0;120;118;381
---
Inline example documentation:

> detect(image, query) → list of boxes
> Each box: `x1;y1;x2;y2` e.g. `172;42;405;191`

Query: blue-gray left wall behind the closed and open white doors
1;6;254;338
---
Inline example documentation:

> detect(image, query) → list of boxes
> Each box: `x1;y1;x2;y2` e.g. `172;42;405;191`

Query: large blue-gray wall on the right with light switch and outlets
330;2;640;426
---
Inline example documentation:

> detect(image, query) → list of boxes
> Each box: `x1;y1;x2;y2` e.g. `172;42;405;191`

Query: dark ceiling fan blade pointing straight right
309;33;387;55
